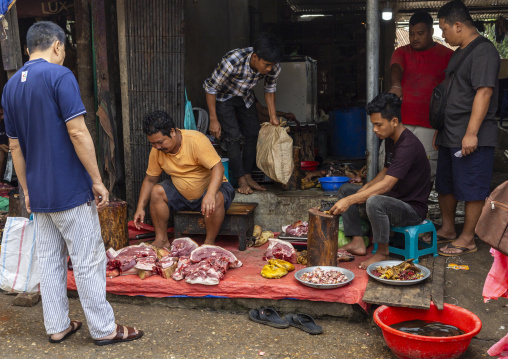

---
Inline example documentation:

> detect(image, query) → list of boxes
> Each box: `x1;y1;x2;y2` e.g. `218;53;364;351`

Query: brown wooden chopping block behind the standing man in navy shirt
99;197;129;251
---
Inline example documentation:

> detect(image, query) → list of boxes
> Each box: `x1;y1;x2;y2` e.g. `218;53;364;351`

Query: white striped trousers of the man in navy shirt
34;201;115;339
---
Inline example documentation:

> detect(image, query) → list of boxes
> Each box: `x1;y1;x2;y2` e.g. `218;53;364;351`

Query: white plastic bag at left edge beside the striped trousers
0;217;40;293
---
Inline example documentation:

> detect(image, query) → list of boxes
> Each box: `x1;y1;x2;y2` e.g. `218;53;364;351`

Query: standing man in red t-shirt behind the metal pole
389;11;453;182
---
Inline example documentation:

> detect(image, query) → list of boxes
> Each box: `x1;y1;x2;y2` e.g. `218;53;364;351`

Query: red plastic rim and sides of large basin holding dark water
374;303;482;359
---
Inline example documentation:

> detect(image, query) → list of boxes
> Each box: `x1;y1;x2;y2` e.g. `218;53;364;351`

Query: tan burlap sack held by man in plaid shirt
256;122;294;184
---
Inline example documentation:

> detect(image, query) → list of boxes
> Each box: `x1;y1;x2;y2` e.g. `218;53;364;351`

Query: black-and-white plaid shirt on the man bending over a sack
203;47;281;108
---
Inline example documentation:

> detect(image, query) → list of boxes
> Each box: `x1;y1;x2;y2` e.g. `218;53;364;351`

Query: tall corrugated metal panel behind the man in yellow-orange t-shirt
123;0;185;213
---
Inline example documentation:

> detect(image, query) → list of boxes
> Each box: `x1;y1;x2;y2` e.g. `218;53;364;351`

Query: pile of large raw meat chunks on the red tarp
106;237;242;285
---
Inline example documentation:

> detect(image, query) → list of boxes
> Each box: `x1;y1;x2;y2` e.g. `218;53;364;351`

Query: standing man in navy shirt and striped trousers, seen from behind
2;21;143;345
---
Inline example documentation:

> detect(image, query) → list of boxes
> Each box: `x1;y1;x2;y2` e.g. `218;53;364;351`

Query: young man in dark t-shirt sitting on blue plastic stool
330;93;430;269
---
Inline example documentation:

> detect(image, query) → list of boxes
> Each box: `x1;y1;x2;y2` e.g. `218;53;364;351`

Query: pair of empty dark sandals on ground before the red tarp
249;308;323;335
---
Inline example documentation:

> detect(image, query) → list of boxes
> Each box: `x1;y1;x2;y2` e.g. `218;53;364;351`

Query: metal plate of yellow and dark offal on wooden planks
367;259;430;285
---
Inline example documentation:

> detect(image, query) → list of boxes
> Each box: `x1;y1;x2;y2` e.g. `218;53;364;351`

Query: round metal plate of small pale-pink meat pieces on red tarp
295;266;355;289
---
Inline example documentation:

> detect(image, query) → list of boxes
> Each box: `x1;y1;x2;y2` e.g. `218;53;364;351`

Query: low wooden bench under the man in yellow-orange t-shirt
174;202;258;251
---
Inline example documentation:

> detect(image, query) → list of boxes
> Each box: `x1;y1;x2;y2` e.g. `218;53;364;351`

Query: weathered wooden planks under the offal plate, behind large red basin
363;256;445;310
